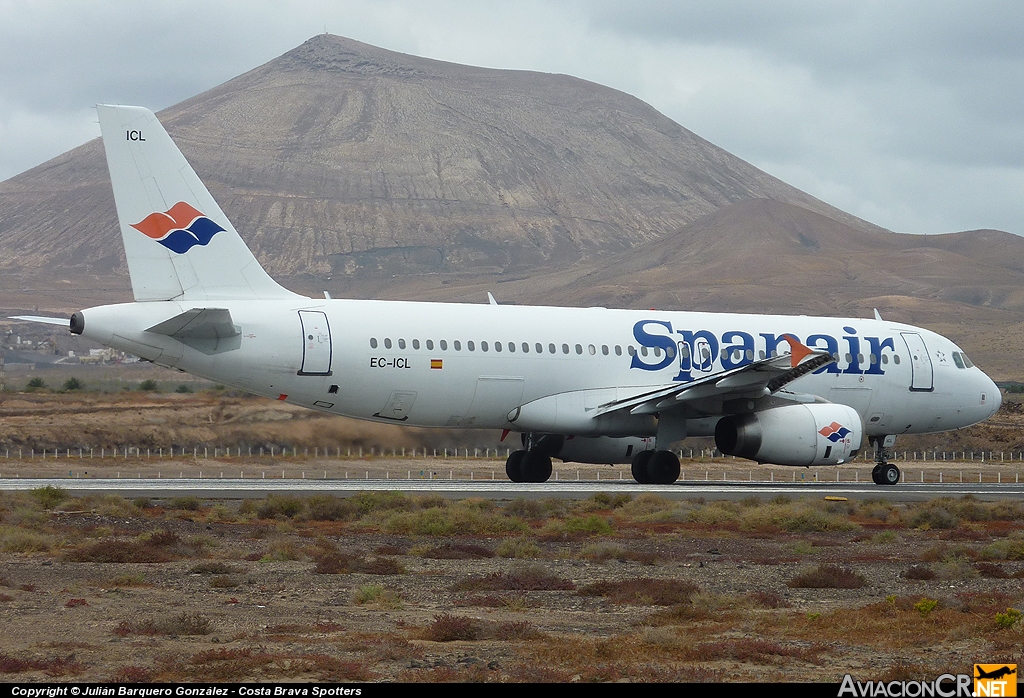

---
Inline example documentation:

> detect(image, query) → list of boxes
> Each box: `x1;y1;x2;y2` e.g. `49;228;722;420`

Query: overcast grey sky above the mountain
0;0;1024;234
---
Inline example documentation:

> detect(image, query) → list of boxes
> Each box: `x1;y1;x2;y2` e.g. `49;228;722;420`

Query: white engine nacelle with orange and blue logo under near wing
715;403;864;466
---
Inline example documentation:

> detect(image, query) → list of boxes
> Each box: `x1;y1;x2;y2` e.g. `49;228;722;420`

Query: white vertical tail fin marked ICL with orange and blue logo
96;104;297;301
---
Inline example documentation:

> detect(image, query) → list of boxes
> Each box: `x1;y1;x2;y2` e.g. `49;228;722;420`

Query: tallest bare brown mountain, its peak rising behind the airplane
0;35;879;278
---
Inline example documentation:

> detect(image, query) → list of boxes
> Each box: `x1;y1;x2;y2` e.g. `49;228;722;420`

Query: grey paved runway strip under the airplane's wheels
0;478;1024;501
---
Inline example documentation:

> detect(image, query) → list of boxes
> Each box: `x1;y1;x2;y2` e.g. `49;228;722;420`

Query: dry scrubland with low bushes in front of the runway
0;489;1024;682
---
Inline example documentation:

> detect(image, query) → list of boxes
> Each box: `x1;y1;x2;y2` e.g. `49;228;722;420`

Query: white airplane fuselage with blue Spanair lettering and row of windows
74;298;1000;436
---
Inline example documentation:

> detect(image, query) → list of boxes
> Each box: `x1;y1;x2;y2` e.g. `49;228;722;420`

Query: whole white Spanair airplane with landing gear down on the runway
8;104;1001;485
